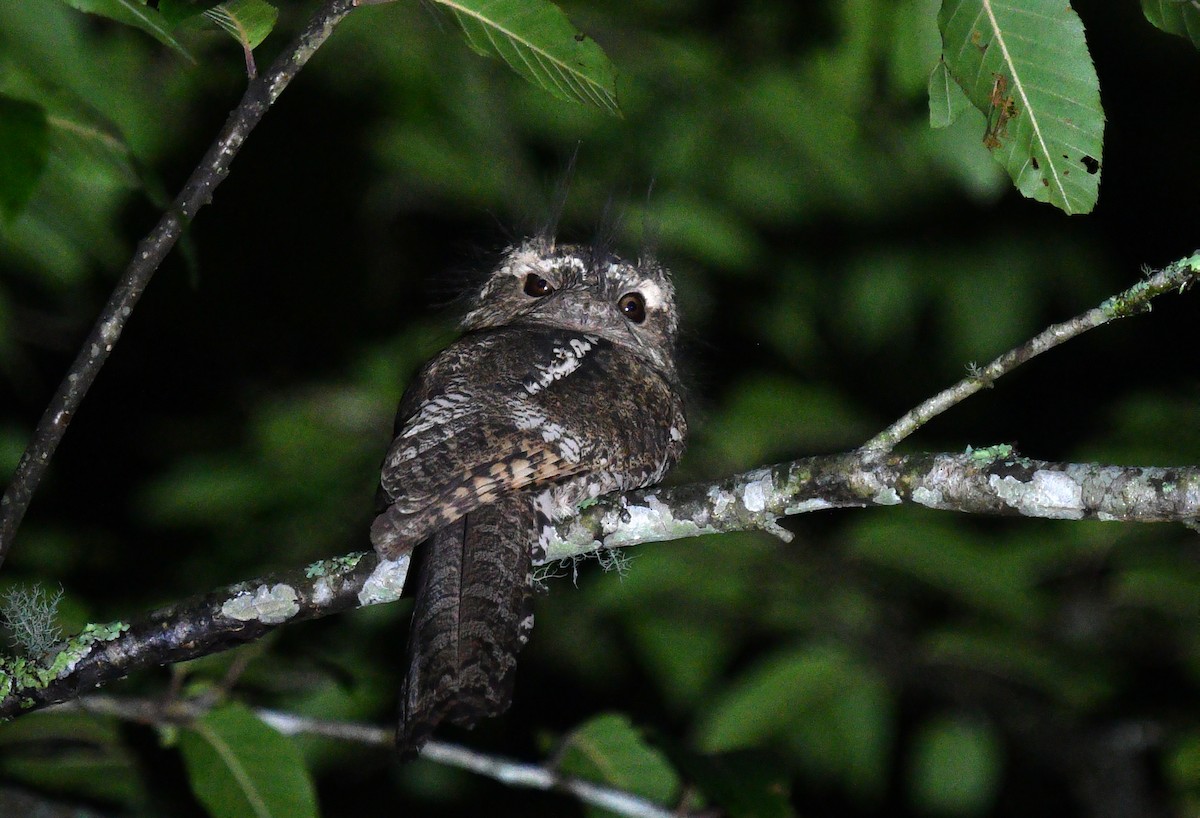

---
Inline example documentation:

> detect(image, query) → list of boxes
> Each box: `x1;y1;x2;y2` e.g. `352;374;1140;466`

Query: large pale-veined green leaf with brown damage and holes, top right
937;0;1104;213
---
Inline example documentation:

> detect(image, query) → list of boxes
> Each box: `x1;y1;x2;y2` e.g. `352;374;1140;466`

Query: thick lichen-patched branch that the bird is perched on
0;445;1200;717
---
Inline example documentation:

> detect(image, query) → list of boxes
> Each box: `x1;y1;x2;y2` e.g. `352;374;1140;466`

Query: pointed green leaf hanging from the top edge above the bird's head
436;0;620;116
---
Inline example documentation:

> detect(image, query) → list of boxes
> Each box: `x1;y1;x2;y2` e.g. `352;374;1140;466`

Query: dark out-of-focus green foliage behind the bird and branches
0;0;1200;817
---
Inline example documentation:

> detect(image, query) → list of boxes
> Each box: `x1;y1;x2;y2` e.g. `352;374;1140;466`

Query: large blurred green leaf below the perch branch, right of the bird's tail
696;645;893;800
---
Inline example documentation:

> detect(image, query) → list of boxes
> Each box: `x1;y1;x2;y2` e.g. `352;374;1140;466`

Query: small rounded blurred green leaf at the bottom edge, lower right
908;717;1003;816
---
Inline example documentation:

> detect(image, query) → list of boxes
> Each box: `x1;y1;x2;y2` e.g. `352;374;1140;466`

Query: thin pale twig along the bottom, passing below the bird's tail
64;694;680;818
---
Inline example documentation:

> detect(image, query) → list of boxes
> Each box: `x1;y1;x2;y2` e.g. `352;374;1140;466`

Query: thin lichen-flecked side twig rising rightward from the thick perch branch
859;253;1200;458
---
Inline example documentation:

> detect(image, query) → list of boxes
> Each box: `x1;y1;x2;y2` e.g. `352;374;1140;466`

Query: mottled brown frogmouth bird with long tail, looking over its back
371;233;688;752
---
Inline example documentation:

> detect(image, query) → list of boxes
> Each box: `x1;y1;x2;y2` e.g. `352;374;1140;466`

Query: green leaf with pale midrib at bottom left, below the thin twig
179;704;317;818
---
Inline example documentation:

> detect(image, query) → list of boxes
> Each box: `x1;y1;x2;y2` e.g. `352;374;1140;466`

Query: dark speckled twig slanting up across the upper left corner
0;0;354;565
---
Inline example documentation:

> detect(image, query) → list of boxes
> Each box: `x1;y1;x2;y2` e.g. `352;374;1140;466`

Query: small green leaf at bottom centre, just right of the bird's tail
559;712;679;805
